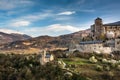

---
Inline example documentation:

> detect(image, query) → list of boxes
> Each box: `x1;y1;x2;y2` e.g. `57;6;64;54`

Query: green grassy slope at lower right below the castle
62;58;120;80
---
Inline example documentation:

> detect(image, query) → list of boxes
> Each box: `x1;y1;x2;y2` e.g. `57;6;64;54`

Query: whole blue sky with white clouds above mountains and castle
0;0;120;37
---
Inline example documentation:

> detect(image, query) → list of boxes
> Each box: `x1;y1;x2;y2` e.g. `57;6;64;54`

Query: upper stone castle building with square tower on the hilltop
91;18;120;39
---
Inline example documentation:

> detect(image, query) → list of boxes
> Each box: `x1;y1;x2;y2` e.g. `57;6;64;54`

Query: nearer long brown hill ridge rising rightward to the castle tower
2;29;90;49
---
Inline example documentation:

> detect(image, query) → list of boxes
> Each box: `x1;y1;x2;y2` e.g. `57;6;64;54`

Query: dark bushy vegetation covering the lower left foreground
0;54;86;80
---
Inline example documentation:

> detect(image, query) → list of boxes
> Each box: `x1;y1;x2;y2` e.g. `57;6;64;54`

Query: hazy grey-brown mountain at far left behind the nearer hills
0;32;31;44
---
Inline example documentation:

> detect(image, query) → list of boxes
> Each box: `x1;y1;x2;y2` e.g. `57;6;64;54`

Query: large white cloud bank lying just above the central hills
24;24;82;37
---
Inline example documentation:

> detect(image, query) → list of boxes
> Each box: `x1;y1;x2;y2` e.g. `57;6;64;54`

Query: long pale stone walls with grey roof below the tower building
74;39;120;54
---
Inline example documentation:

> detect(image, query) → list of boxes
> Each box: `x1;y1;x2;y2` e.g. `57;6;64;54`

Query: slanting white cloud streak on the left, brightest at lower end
4;10;54;27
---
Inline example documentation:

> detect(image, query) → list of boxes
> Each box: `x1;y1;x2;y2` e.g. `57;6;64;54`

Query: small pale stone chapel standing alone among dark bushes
40;51;54;65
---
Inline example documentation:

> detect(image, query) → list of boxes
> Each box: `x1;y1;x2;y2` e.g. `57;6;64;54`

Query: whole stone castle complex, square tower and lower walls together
69;18;120;54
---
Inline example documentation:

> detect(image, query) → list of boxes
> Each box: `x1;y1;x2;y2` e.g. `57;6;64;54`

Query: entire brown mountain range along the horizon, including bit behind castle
0;21;120;50
